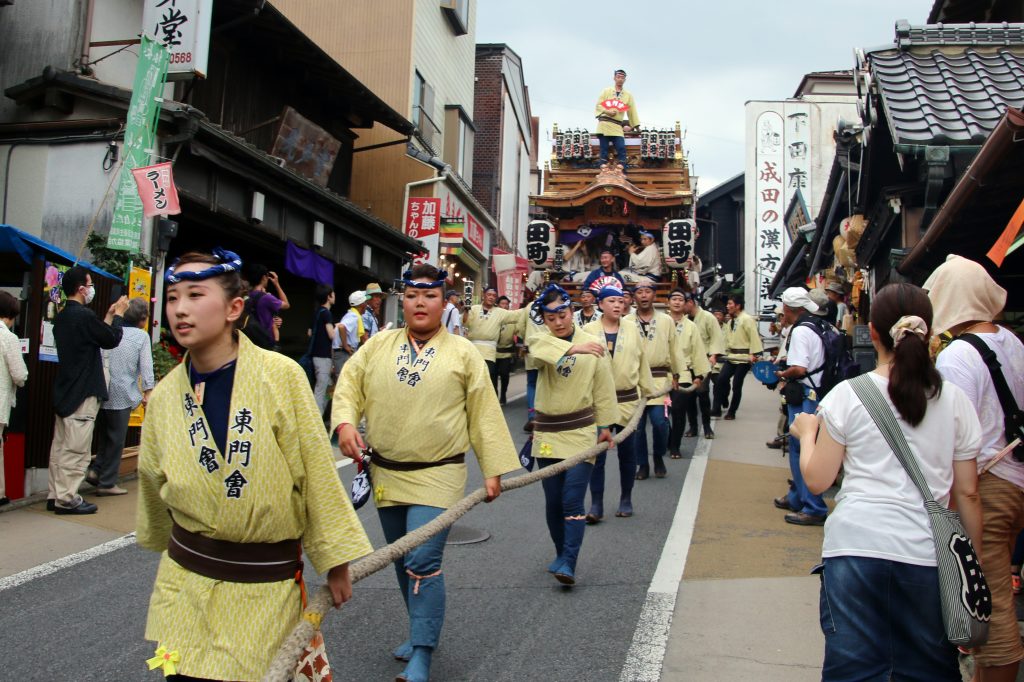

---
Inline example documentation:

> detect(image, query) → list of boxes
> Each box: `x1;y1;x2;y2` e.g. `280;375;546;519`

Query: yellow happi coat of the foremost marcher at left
136;335;373;680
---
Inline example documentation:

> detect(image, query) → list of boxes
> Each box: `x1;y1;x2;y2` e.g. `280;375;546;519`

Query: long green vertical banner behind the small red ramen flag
106;35;170;253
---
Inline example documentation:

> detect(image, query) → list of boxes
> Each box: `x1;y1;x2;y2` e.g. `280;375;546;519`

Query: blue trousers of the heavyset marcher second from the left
377;505;449;648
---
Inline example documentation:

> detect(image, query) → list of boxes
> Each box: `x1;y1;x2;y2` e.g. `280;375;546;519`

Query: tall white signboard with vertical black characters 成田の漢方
753;112;792;313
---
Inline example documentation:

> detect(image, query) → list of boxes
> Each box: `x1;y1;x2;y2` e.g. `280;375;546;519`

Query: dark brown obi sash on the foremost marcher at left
167;523;302;583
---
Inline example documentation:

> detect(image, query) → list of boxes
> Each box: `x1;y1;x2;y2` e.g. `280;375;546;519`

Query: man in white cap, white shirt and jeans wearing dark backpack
774;287;828;525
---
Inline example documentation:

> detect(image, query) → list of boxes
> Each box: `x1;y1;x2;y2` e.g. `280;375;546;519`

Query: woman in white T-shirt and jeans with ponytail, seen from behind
791;284;981;682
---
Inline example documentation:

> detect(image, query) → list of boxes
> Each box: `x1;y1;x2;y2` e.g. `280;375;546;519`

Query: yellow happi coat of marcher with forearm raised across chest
529;329;618;460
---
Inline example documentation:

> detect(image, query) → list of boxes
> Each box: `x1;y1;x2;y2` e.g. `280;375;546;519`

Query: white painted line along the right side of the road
618;438;712;682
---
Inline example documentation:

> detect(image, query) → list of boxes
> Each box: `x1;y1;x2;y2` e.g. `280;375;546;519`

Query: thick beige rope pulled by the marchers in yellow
263;391;668;682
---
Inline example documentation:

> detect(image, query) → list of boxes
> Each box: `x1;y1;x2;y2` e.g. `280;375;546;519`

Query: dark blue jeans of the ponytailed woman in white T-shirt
819;557;961;682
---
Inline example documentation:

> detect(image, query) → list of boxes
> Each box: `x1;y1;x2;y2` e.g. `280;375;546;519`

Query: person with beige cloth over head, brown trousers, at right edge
924;255;1024;680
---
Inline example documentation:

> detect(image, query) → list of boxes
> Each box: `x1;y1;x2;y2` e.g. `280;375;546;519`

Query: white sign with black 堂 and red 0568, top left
142;0;213;81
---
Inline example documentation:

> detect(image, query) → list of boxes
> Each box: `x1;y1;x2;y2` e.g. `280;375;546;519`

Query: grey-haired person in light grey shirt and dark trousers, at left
85;298;157;496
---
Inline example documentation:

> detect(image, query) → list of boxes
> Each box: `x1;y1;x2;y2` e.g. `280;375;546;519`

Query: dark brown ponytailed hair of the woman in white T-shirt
871;284;942;426
